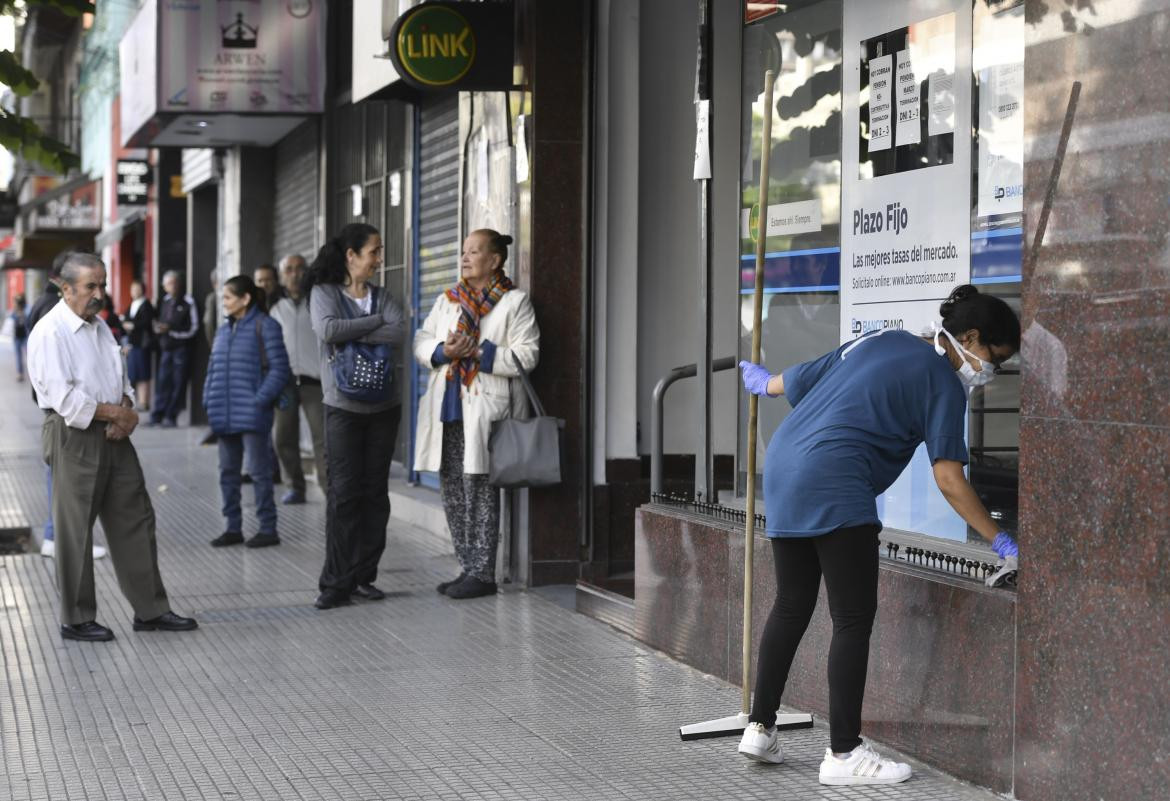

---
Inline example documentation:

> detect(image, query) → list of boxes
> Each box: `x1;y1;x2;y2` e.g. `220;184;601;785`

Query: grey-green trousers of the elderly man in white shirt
41;413;171;626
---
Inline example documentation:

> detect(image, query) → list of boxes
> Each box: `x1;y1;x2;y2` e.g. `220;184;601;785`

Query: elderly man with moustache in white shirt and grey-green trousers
28;253;198;642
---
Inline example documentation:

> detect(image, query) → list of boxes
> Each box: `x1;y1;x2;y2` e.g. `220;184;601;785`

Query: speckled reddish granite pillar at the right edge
1016;2;1170;801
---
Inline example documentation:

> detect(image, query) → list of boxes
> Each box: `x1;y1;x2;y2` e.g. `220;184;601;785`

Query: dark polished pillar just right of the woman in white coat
518;0;591;585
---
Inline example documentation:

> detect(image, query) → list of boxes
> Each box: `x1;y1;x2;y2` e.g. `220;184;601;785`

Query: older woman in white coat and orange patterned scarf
414;228;541;599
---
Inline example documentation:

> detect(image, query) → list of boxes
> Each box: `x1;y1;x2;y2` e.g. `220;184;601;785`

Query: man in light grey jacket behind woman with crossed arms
269;255;329;504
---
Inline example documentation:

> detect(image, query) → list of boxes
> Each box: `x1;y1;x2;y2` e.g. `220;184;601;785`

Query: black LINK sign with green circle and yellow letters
390;2;514;90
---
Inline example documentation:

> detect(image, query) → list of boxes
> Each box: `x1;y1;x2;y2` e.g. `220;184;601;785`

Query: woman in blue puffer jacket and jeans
204;275;289;548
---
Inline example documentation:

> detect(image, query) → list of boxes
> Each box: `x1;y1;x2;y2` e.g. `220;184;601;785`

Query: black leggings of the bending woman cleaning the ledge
750;525;881;753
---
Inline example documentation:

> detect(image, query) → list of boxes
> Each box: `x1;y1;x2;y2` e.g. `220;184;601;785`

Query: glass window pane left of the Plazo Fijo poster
737;0;841;495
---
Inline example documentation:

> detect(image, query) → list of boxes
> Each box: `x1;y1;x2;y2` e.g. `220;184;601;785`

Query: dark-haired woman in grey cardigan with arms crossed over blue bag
305;222;406;609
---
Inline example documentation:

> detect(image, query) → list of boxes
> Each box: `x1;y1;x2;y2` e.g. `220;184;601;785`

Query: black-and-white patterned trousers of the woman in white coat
439;422;500;582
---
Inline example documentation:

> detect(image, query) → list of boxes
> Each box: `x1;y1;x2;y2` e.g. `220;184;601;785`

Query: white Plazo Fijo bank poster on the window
840;0;971;540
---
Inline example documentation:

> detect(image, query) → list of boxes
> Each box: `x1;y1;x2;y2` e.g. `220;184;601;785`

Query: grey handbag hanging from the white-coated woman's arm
488;353;565;489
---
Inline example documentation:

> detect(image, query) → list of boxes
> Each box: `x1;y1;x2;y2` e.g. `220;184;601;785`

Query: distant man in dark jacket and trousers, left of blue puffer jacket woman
150;270;199;428
